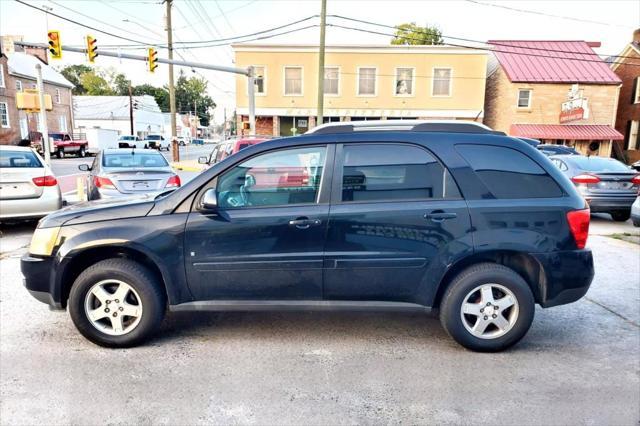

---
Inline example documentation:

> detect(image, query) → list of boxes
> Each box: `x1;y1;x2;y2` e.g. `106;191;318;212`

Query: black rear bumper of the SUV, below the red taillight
533;249;595;308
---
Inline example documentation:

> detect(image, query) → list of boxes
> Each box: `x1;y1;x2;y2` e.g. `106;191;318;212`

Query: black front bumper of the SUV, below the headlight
20;253;64;310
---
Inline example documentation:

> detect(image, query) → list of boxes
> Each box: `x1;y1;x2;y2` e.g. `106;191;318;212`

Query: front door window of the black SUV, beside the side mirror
217;147;326;208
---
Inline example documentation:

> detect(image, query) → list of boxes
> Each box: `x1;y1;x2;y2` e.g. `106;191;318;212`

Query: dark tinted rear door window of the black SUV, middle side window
342;144;460;201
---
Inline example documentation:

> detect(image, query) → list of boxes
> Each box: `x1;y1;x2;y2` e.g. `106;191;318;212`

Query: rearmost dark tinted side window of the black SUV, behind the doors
456;145;562;198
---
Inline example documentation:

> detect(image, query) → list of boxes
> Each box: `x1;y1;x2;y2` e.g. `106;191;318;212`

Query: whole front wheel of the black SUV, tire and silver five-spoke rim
68;259;166;348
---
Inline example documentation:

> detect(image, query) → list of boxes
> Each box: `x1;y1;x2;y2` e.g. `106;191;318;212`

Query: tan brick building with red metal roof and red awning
484;40;623;157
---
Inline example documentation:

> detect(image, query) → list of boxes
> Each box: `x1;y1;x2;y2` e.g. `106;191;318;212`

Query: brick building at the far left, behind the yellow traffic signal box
0;45;73;145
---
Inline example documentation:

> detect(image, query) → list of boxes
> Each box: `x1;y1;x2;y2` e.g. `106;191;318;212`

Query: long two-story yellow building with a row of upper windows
232;44;487;135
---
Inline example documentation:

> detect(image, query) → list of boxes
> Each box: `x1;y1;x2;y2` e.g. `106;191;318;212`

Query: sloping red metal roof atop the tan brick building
489;40;621;84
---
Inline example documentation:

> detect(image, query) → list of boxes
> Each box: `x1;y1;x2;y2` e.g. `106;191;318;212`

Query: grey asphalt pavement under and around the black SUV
0;217;640;425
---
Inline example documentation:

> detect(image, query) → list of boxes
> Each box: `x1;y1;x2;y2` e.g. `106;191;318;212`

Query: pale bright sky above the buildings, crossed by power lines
0;0;640;122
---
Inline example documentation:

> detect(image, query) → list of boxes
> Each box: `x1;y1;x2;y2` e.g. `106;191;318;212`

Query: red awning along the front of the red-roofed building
509;124;624;141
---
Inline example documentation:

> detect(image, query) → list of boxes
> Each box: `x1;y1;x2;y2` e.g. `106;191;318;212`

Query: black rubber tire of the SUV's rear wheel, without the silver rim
440;264;535;352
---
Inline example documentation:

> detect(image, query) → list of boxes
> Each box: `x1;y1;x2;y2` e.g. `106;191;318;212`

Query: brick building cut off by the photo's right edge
611;29;640;163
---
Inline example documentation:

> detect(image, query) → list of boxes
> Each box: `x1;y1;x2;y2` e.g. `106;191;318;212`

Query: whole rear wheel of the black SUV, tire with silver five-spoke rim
440;263;535;352
